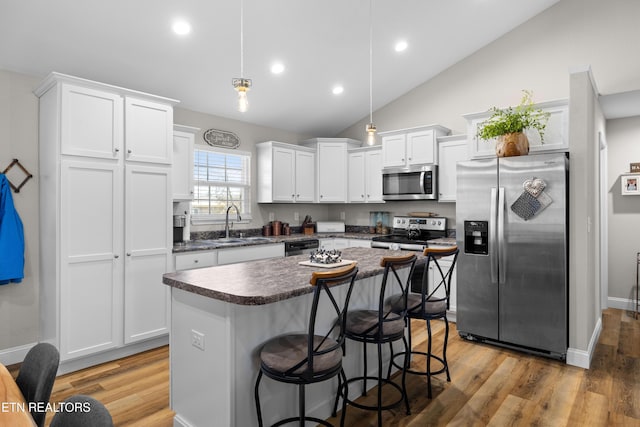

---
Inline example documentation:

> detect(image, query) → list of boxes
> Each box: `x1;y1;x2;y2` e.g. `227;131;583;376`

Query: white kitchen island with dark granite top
163;248;424;427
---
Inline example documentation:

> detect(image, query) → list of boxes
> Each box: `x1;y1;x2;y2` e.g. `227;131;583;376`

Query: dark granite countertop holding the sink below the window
173;233;379;254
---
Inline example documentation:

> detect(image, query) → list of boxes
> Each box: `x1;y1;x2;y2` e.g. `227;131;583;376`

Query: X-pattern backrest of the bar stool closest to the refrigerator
418;246;458;313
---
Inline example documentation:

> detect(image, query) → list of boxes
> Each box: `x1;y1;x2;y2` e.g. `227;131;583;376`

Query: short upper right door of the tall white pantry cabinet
125;96;173;164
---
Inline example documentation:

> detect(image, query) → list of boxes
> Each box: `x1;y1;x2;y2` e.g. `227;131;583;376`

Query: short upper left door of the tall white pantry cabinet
60;83;124;159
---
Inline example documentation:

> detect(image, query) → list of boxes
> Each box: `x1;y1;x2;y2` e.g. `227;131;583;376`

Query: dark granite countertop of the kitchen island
162;246;424;305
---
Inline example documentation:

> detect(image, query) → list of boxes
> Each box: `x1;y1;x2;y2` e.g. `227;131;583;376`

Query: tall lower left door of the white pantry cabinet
59;160;123;360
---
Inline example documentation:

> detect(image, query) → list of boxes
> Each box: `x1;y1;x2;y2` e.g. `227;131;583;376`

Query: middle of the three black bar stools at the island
333;253;417;426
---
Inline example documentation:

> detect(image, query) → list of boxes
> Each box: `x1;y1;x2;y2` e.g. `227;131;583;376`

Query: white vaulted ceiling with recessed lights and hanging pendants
0;0;558;136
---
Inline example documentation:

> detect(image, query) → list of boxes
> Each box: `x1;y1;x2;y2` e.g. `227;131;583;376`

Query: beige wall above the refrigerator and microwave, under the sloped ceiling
339;0;640;139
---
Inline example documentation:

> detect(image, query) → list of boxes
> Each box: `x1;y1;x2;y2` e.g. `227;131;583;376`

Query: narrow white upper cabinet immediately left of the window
171;125;200;200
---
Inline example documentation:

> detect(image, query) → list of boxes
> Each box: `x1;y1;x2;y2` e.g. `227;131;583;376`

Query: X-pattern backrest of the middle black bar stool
374;253;418;337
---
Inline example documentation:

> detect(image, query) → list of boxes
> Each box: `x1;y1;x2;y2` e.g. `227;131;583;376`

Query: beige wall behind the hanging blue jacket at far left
0;70;40;361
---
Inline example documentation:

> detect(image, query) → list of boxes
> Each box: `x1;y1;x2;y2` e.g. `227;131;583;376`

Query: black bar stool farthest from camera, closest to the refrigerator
386;246;458;399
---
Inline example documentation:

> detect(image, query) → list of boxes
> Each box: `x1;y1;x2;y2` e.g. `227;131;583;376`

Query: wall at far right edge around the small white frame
607;117;640;309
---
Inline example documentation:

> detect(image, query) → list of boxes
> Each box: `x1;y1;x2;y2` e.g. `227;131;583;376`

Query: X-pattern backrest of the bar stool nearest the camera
289;262;358;378
